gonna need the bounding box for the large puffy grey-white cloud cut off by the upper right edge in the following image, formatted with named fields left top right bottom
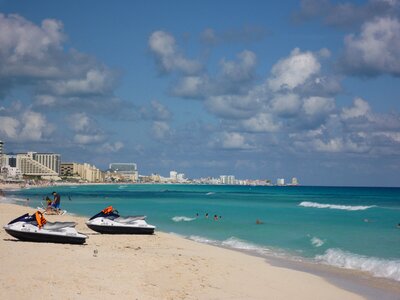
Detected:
left=341, top=18, right=400, bottom=76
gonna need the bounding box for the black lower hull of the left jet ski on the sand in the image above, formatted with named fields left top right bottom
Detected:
left=4, top=228, right=86, bottom=244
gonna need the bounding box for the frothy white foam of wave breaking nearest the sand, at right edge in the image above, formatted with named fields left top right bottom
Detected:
left=315, top=249, right=400, bottom=281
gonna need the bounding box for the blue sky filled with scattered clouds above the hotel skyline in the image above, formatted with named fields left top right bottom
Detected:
left=0, top=0, right=400, bottom=186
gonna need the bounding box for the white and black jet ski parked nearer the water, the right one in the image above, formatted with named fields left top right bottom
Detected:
left=86, top=206, right=156, bottom=234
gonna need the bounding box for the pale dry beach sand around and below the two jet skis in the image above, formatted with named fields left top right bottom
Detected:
left=0, top=204, right=376, bottom=299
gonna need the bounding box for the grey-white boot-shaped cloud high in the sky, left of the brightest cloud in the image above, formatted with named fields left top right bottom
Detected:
left=149, top=30, right=202, bottom=74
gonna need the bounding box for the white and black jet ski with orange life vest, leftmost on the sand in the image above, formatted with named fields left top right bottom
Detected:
left=4, top=211, right=87, bottom=244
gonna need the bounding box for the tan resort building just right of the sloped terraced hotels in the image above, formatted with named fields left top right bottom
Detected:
left=61, top=162, right=104, bottom=182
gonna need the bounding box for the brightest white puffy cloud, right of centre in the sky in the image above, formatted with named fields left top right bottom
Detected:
left=268, top=48, right=321, bottom=92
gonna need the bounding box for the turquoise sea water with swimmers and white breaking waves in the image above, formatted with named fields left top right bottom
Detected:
left=6, top=185, right=400, bottom=281
